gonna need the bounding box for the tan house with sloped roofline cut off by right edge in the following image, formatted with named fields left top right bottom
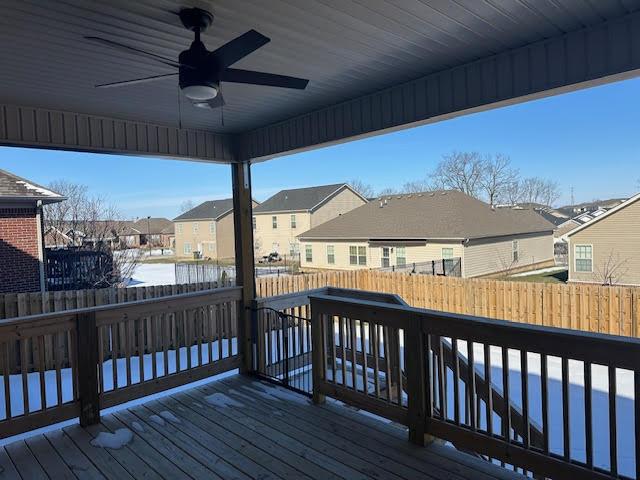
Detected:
left=566, top=193, right=640, bottom=285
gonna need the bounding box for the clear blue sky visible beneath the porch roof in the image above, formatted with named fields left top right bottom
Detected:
left=0, top=75, right=640, bottom=218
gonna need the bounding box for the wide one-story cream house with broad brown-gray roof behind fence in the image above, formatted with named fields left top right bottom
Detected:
left=299, top=190, right=554, bottom=277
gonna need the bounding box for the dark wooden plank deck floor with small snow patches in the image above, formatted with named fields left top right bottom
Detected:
left=0, top=376, right=523, bottom=480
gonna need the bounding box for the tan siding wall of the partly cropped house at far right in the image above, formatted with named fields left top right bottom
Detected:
left=569, top=201, right=640, bottom=285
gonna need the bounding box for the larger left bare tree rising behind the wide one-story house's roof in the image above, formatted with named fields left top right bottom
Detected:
left=430, top=152, right=484, bottom=198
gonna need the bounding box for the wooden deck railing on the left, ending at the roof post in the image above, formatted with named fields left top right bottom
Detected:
left=0, top=287, right=241, bottom=438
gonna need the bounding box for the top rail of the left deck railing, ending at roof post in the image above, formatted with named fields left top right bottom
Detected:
left=0, top=287, right=242, bottom=327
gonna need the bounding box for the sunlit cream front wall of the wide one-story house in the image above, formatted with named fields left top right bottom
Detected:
left=300, top=240, right=462, bottom=270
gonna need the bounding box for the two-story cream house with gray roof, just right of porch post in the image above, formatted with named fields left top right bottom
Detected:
left=253, top=183, right=367, bottom=256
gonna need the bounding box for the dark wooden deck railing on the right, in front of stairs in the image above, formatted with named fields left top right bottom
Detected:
left=311, top=295, right=640, bottom=478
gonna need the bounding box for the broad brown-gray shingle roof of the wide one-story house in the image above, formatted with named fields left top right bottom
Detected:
left=299, top=190, right=554, bottom=240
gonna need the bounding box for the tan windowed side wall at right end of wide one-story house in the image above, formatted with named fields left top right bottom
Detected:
left=462, top=232, right=553, bottom=277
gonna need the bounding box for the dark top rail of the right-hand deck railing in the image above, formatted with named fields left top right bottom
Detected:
left=311, top=295, right=640, bottom=370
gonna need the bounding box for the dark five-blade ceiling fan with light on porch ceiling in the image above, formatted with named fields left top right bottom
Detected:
left=84, top=8, right=309, bottom=108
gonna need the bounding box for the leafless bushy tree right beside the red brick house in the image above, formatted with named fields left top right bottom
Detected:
left=44, top=180, right=139, bottom=285
